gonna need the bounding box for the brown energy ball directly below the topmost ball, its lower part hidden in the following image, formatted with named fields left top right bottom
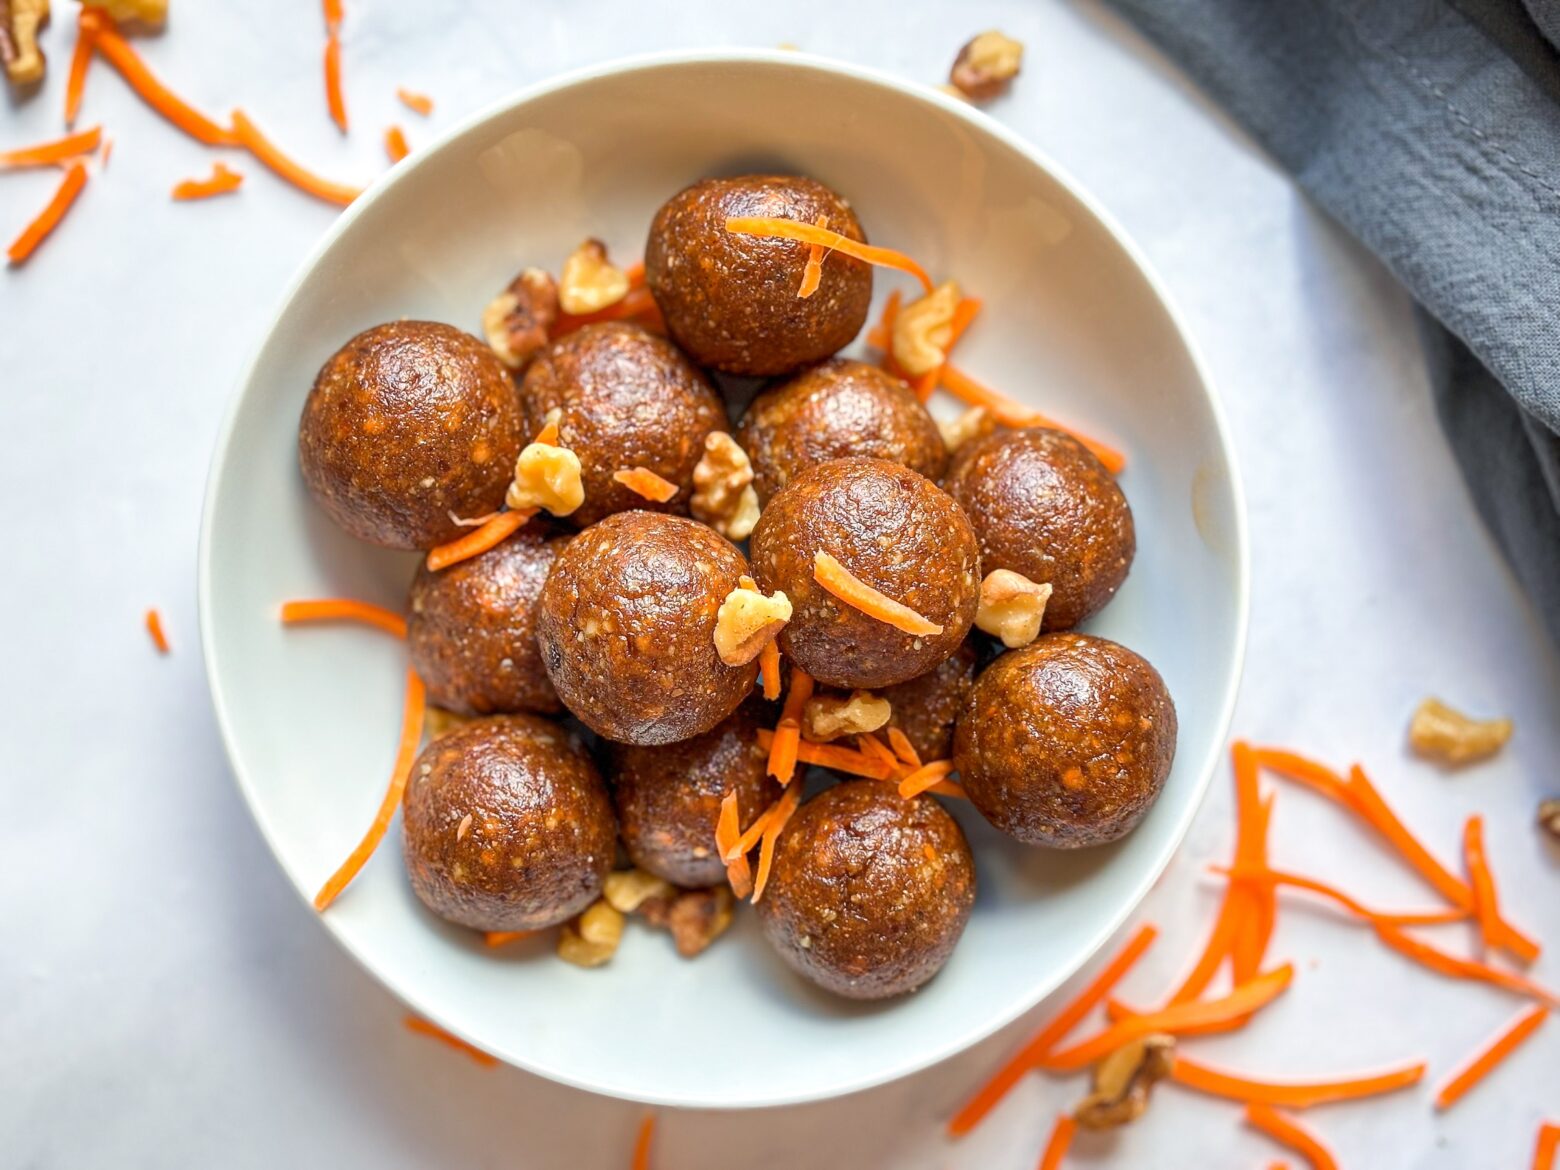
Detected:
left=736, top=357, right=948, bottom=504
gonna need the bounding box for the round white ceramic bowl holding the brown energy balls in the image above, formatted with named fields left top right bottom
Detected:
left=200, top=51, right=1246, bottom=1108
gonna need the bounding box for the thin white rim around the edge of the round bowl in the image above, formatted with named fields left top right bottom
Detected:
left=197, top=47, right=1251, bottom=1111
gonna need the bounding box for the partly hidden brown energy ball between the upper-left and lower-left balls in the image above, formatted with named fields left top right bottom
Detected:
left=406, top=521, right=569, bottom=714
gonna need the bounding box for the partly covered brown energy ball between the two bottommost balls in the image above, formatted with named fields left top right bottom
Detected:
left=608, top=700, right=780, bottom=886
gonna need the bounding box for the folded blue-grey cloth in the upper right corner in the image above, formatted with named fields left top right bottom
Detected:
left=1106, top=0, right=1560, bottom=643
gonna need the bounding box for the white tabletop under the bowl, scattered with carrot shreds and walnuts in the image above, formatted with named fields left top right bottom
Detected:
left=0, top=0, right=1560, bottom=1170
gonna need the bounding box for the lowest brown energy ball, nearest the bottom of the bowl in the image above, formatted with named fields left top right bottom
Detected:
left=758, top=780, right=975, bottom=1000
